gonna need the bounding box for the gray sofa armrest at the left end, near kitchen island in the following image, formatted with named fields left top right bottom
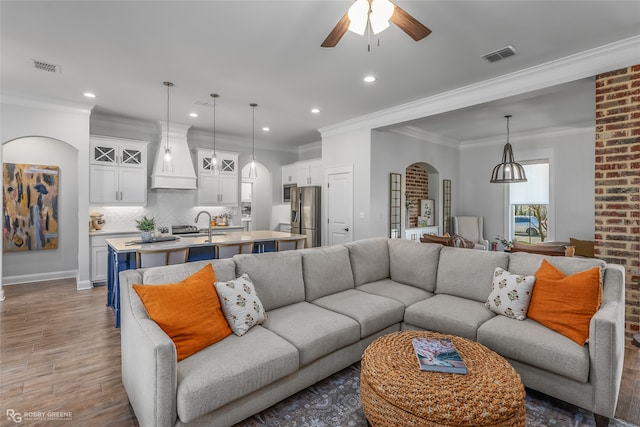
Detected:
left=120, top=270, right=178, bottom=427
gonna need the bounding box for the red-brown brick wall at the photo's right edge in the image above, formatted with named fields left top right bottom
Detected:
left=595, top=65, right=640, bottom=346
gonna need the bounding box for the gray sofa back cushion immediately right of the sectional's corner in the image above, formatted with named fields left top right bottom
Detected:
left=388, top=239, right=442, bottom=292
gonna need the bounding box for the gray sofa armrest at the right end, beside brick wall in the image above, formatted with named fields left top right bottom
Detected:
left=589, top=264, right=625, bottom=418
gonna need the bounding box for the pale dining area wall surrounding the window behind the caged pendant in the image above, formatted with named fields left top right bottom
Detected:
left=460, top=125, right=595, bottom=241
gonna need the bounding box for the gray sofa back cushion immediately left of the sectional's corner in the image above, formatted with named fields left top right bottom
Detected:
left=344, top=237, right=389, bottom=286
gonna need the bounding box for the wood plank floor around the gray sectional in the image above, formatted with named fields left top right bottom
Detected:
left=0, top=280, right=640, bottom=427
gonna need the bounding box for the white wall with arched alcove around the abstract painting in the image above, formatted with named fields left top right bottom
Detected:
left=0, top=94, right=91, bottom=289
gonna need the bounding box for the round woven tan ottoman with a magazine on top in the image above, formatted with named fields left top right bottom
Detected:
left=360, top=331, right=526, bottom=427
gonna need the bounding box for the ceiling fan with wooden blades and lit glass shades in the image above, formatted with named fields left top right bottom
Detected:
left=321, top=0, right=431, bottom=47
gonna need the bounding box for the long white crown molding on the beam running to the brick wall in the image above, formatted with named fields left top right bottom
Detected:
left=318, top=36, right=640, bottom=138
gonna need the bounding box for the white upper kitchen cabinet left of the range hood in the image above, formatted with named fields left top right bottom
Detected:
left=89, top=135, right=147, bottom=205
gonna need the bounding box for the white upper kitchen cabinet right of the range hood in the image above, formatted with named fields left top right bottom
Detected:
left=198, top=149, right=239, bottom=206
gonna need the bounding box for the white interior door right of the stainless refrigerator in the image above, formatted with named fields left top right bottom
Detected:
left=327, top=171, right=353, bottom=245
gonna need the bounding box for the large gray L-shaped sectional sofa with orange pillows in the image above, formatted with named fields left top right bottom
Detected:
left=120, top=238, right=624, bottom=426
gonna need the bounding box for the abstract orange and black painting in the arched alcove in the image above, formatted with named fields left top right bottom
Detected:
left=2, top=163, right=60, bottom=252
